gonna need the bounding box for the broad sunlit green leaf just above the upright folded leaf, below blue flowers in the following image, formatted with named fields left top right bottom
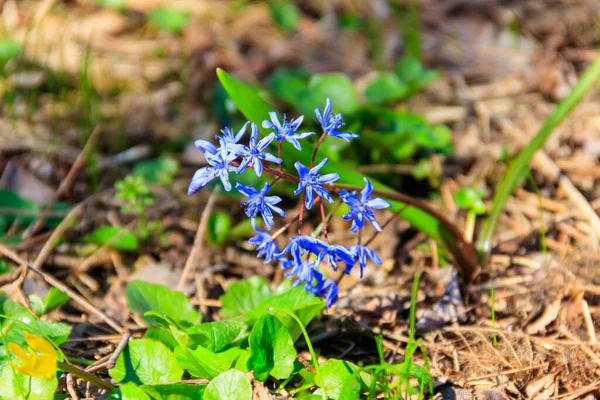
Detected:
left=248, top=287, right=325, bottom=340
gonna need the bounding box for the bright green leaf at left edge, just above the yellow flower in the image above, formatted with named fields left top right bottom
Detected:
left=0, top=292, right=71, bottom=346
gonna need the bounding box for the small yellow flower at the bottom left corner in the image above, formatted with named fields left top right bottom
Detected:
left=8, top=332, right=58, bottom=379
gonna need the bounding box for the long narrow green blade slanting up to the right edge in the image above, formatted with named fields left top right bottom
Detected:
left=477, top=57, right=600, bottom=255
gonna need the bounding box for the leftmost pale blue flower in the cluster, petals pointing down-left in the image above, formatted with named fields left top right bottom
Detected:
left=188, top=142, right=237, bottom=194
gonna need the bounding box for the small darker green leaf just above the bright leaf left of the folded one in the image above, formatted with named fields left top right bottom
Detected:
left=186, top=318, right=248, bottom=351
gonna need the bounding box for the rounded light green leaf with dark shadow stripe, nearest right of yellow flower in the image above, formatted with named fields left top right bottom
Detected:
left=108, top=339, right=183, bottom=385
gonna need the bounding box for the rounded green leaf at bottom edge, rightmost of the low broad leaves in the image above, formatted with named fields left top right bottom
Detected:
left=315, top=359, right=361, bottom=400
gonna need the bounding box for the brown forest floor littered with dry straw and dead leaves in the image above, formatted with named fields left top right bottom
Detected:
left=0, top=0, right=600, bottom=399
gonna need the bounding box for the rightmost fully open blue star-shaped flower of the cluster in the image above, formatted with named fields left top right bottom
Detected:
left=340, top=178, right=390, bottom=232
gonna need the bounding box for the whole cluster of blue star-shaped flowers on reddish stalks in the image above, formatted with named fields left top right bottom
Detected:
left=188, top=99, right=390, bottom=308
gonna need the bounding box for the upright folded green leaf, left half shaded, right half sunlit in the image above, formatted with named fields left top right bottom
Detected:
left=247, top=314, right=296, bottom=381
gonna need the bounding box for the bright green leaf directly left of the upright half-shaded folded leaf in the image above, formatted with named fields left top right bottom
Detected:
left=175, top=346, right=245, bottom=379
